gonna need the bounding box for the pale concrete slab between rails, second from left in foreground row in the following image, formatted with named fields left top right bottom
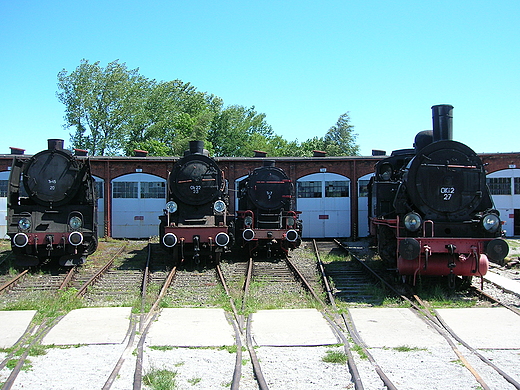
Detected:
left=42, top=307, right=132, bottom=345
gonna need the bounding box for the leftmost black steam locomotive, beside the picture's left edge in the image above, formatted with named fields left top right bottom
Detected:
left=7, top=139, right=98, bottom=266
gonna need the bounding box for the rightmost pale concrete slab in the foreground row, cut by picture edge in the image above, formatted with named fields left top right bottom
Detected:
left=437, top=307, right=520, bottom=349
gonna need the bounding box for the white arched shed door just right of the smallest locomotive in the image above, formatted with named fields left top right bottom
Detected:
left=296, top=172, right=351, bottom=238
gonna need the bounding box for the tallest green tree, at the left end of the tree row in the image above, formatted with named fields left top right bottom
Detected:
left=57, top=59, right=151, bottom=155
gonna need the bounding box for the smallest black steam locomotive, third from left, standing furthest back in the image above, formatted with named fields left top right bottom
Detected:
left=235, top=160, right=302, bottom=256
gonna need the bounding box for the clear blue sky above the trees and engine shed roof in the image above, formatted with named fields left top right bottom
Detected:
left=0, top=0, right=520, bottom=155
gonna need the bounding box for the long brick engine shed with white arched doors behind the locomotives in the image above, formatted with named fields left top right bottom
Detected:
left=0, top=148, right=520, bottom=238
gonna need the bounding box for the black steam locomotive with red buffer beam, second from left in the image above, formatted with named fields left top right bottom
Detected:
left=159, top=141, right=230, bottom=263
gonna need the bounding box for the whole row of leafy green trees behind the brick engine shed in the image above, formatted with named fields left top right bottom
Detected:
left=57, top=59, right=359, bottom=156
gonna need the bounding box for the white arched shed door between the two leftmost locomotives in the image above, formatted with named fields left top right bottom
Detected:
left=112, top=173, right=166, bottom=238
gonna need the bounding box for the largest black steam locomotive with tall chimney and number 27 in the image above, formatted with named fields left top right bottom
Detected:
left=369, top=105, right=509, bottom=286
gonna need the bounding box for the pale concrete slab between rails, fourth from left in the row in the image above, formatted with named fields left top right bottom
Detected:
left=251, top=309, right=340, bottom=347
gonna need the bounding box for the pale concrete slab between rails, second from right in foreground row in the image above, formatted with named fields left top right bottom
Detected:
left=349, top=308, right=446, bottom=348
